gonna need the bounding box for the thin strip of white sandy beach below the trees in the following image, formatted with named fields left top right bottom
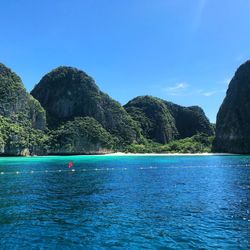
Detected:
left=102, top=152, right=235, bottom=156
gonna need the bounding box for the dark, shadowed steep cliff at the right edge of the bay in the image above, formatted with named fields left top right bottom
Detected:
left=214, top=61, right=250, bottom=154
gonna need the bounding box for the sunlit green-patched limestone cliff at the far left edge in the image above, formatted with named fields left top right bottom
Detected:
left=0, top=64, right=46, bottom=155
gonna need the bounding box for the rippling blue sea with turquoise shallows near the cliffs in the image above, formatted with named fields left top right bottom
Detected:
left=0, top=156, right=250, bottom=249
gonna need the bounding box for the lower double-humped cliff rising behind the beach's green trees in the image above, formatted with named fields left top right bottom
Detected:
left=124, top=96, right=214, bottom=143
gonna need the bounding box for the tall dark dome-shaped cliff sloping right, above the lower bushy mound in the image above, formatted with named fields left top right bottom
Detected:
left=31, top=67, right=141, bottom=144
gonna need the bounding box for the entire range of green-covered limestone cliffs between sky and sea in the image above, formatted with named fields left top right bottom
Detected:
left=0, top=61, right=250, bottom=155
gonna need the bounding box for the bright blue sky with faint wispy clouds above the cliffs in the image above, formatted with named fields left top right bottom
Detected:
left=0, top=0, right=250, bottom=122
